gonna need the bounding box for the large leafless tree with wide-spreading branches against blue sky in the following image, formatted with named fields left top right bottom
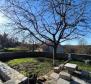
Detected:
left=1, top=0, right=90, bottom=64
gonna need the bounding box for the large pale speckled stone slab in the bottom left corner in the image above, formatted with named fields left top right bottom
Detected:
left=0, top=62, right=27, bottom=84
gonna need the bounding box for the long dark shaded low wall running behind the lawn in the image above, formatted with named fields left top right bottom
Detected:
left=0, top=52, right=91, bottom=61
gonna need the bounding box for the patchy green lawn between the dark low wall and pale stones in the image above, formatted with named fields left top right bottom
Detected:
left=6, top=57, right=91, bottom=76
